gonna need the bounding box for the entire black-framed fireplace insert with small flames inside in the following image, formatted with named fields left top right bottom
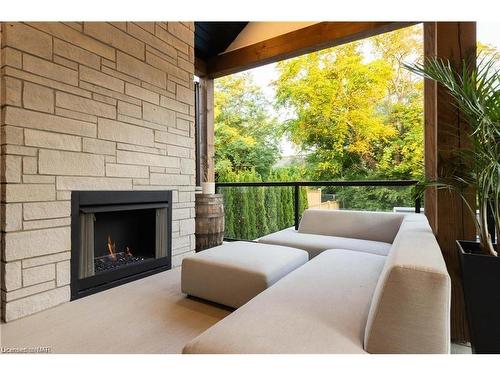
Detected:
left=71, top=191, right=172, bottom=299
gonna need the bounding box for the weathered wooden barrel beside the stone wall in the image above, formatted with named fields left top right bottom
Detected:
left=195, top=194, right=224, bottom=252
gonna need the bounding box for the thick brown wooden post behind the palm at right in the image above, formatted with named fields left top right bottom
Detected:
left=424, top=22, right=476, bottom=342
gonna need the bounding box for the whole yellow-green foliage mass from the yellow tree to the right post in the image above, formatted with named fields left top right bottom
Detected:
left=275, top=27, right=423, bottom=187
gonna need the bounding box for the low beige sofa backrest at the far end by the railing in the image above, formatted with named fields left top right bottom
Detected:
left=299, top=209, right=404, bottom=243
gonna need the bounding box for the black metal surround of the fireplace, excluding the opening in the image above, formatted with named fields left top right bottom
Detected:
left=71, top=190, right=172, bottom=300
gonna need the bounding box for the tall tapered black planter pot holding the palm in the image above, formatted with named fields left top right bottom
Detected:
left=457, top=241, right=500, bottom=354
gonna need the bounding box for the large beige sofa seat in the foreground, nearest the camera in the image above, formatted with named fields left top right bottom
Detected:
left=183, top=250, right=386, bottom=354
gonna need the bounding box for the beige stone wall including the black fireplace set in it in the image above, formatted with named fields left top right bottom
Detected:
left=0, top=22, right=195, bottom=321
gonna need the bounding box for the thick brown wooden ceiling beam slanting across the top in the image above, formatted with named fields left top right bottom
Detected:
left=207, top=22, right=418, bottom=78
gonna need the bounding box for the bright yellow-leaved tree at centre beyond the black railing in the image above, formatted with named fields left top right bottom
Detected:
left=275, top=43, right=395, bottom=179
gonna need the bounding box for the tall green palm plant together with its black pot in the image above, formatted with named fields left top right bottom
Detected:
left=406, top=55, right=500, bottom=353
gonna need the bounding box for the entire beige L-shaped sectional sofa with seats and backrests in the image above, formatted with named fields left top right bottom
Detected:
left=184, top=210, right=451, bottom=353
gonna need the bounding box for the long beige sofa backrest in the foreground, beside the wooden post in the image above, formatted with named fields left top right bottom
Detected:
left=364, top=215, right=451, bottom=353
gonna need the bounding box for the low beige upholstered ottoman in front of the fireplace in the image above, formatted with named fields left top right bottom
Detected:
left=181, top=242, right=309, bottom=308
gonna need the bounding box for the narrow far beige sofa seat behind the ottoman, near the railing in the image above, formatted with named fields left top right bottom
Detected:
left=258, top=228, right=392, bottom=259
